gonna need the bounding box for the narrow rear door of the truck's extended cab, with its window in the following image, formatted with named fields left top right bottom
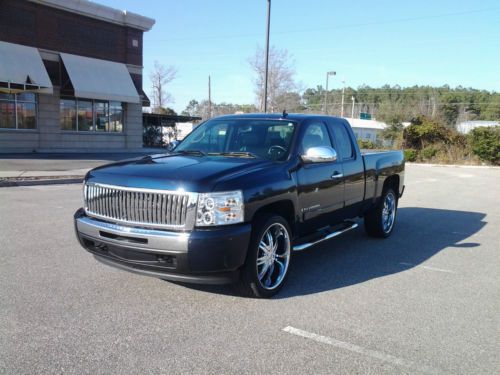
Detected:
left=328, top=119, right=365, bottom=212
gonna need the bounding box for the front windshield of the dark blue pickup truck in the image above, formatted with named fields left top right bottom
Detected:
left=174, top=119, right=295, bottom=161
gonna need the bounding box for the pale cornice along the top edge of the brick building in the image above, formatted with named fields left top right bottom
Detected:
left=29, top=0, right=155, bottom=31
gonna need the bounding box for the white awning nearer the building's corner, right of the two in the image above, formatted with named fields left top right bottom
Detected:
left=60, top=53, right=141, bottom=103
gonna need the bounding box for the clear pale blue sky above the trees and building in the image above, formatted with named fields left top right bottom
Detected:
left=97, top=0, right=500, bottom=113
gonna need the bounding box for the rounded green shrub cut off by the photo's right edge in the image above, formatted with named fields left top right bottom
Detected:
left=469, top=126, right=500, bottom=165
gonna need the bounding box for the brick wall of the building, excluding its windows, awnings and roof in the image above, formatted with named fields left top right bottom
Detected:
left=0, top=0, right=148, bottom=152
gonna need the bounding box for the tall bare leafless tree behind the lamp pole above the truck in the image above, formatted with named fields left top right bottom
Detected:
left=248, top=46, right=297, bottom=112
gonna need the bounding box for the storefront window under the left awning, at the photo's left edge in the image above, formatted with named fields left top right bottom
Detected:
left=0, top=93, right=37, bottom=129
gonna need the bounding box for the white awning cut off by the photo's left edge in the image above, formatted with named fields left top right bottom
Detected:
left=0, top=41, right=52, bottom=94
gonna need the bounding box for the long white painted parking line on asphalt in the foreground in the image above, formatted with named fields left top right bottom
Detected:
left=283, top=326, right=444, bottom=374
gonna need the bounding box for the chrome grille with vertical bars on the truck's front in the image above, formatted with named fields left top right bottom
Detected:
left=84, top=184, right=196, bottom=229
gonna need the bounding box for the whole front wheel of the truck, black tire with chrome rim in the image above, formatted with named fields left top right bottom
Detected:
left=239, top=214, right=292, bottom=298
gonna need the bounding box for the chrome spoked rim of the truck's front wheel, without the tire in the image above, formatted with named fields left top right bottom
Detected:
left=256, top=223, right=291, bottom=290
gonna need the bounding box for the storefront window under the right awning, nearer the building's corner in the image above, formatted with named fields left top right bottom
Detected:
left=60, top=98, right=124, bottom=132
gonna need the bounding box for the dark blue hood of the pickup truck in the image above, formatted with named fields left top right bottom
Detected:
left=87, top=155, right=274, bottom=192
